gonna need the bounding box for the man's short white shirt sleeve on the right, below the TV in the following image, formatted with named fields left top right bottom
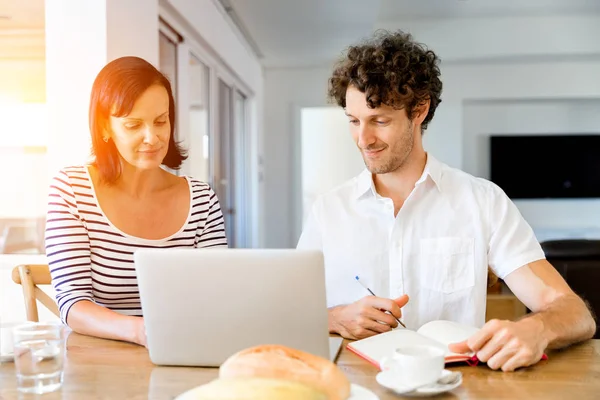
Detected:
left=488, top=184, right=545, bottom=279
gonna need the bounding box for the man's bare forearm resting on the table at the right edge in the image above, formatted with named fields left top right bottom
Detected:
left=522, top=294, right=596, bottom=349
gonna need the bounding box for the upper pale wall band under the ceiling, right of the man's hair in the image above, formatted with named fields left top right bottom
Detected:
left=375, top=15, right=600, bottom=62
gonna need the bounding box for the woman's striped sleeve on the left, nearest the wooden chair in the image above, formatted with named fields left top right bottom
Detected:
left=46, top=171, right=94, bottom=324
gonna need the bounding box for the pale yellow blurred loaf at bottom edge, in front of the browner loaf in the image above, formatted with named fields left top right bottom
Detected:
left=177, top=378, right=327, bottom=400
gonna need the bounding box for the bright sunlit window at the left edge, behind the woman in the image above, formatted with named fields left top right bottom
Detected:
left=0, top=89, right=48, bottom=254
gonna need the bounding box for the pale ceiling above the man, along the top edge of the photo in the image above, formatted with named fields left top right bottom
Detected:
left=226, top=0, right=600, bottom=67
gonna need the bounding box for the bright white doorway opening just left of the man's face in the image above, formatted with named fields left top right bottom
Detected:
left=301, top=107, right=365, bottom=221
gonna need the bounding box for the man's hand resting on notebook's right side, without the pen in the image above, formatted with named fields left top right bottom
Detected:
left=448, top=318, right=548, bottom=372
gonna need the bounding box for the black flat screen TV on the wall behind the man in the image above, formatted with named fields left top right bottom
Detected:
left=490, top=134, right=600, bottom=199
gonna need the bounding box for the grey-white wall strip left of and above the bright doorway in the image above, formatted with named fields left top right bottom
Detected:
left=264, top=68, right=331, bottom=248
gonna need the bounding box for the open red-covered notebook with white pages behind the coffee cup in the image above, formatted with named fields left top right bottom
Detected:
left=346, top=321, right=546, bottom=369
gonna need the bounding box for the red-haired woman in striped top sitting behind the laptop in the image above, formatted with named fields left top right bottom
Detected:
left=46, top=57, right=227, bottom=346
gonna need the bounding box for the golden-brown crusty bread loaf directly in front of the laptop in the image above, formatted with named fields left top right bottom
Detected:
left=219, top=345, right=350, bottom=400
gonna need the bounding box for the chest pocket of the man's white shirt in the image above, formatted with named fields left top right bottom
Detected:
left=419, top=237, right=475, bottom=293
